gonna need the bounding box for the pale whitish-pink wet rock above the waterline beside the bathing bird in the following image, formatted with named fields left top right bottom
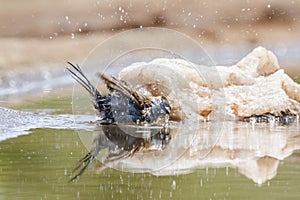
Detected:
left=119, top=47, right=300, bottom=120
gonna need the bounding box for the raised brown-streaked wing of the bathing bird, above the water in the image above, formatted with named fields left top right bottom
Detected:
left=98, top=74, right=151, bottom=109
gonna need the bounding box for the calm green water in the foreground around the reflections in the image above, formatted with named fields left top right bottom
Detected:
left=0, top=98, right=300, bottom=200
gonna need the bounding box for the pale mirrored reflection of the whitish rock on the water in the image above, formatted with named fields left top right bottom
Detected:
left=96, top=121, right=300, bottom=184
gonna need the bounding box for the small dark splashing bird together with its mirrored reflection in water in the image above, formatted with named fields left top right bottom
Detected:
left=67, top=62, right=171, bottom=181
